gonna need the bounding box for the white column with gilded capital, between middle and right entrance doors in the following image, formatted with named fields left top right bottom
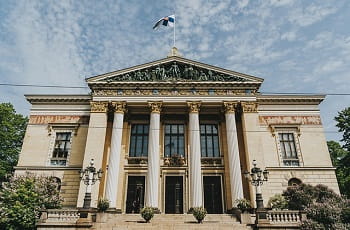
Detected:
left=187, top=102, right=203, bottom=208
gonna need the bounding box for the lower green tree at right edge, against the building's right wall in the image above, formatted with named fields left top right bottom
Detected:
left=327, top=141, right=350, bottom=198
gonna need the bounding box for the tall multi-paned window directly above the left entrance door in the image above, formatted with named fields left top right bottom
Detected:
left=129, top=124, right=149, bottom=157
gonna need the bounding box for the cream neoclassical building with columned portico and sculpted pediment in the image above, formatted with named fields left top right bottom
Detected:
left=16, top=50, right=339, bottom=213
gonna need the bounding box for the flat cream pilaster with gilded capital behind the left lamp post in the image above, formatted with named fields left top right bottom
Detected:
left=77, top=101, right=108, bottom=207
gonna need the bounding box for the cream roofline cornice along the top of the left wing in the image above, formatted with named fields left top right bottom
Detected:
left=24, top=94, right=91, bottom=104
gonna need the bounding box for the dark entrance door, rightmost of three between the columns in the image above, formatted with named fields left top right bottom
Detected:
left=203, top=176, right=222, bottom=214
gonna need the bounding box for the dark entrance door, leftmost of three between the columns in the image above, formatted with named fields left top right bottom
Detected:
left=125, top=176, right=145, bottom=213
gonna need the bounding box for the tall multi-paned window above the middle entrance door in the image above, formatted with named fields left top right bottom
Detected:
left=164, top=124, right=185, bottom=157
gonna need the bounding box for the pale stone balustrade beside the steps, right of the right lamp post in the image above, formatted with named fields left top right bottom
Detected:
left=267, top=210, right=306, bottom=224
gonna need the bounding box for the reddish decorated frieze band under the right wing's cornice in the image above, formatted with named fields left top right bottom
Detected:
left=259, top=116, right=322, bottom=125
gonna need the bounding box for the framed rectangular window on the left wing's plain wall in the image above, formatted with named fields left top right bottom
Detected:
left=51, top=132, right=72, bottom=166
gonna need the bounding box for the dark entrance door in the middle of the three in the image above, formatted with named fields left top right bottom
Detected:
left=165, top=176, right=183, bottom=214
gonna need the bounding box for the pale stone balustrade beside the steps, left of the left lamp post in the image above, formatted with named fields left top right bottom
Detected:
left=40, top=209, right=79, bottom=223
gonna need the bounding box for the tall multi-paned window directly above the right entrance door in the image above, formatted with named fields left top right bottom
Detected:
left=200, top=124, right=220, bottom=157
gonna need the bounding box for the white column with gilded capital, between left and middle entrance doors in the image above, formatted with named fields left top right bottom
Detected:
left=145, top=102, right=162, bottom=209
